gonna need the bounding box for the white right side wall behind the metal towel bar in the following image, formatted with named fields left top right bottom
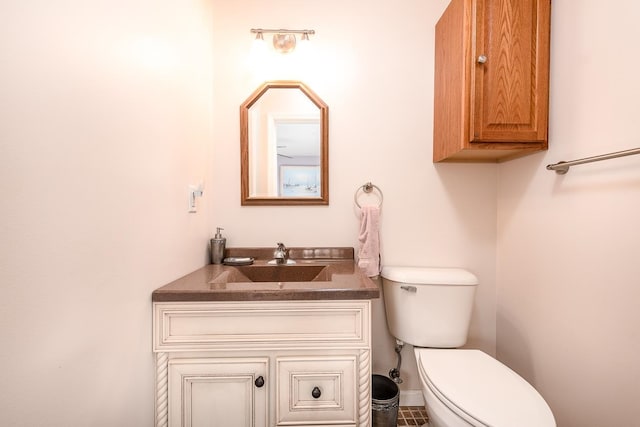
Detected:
left=497, top=0, right=640, bottom=427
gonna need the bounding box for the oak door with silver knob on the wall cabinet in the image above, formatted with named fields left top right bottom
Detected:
left=471, top=0, right=551, bottom=148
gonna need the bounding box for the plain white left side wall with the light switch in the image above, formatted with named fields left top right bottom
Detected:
left=0, top=0, right=212, bottom=427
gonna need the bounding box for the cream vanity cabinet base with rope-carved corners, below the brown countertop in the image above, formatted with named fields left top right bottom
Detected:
left=153, top=300, right=371, bottom=427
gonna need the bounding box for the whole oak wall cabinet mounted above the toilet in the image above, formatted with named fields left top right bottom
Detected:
left=433, top=0, right=551, bottom=162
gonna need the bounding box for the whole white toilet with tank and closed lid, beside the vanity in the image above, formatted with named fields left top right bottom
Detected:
left=381, top=266, right=556, bottom=427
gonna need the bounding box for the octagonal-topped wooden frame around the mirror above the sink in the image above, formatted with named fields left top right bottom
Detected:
left=240, top=81, right=329, bottom=206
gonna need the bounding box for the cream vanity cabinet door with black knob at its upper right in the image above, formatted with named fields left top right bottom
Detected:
left=168, top=358, right=269, bottom=427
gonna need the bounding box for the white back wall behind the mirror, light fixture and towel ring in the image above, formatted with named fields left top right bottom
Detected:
left=213, top=0, right=497, bottom=389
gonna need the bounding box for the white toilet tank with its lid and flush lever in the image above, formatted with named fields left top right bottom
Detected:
left=381, top=266, right=478, bottom=348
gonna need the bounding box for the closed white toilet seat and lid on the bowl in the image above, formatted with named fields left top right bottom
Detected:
left=415, top=348, right=556, bottom=427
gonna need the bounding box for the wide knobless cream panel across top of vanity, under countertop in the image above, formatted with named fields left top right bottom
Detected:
left=153, top=300, right=370, bottom=352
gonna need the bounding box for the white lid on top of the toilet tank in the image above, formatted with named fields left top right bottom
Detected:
left=382, top=265, right=478, bottom=286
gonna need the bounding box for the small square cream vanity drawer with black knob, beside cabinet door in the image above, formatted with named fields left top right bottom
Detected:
left=276, top=354, right=358, bottom=426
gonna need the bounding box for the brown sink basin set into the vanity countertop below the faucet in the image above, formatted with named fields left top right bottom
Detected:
left=236, top=265, right=330, bottom=282
